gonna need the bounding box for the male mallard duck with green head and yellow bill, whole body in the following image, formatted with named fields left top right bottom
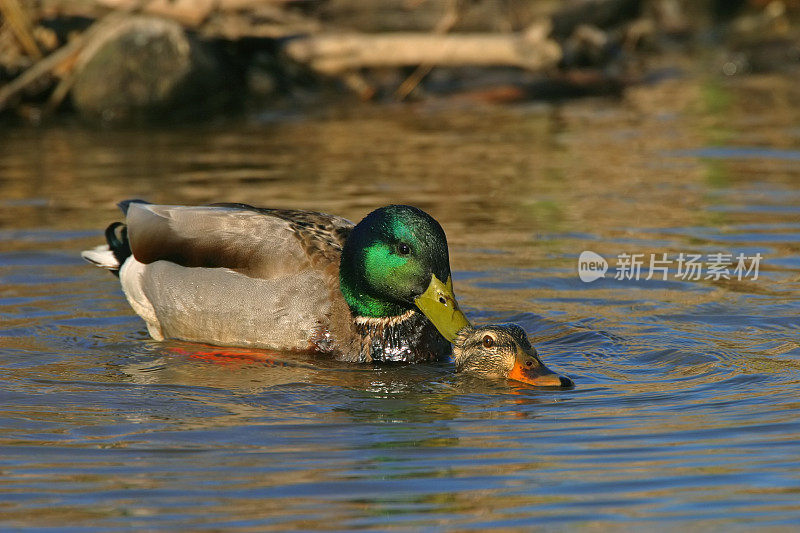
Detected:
left=81, top=200, right=469, bottom=362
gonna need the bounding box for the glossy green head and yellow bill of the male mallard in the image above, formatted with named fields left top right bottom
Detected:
left=339, top=205, right=469, bottom=341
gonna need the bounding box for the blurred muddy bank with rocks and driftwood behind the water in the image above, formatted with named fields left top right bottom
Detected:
left=0, top=0, right=800, bottom=123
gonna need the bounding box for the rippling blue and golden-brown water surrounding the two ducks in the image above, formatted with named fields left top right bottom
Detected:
left=0, top=79, right=800, bottom=531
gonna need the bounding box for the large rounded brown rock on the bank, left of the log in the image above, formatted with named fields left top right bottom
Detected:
left=71, top=16, right=235, bottom=123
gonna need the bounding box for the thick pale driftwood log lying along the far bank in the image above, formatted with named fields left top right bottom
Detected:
left=284, top=24, right=561, bottom=75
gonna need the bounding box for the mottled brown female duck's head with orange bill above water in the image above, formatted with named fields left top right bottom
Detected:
left=453, top=324, right=573, bottom=388
